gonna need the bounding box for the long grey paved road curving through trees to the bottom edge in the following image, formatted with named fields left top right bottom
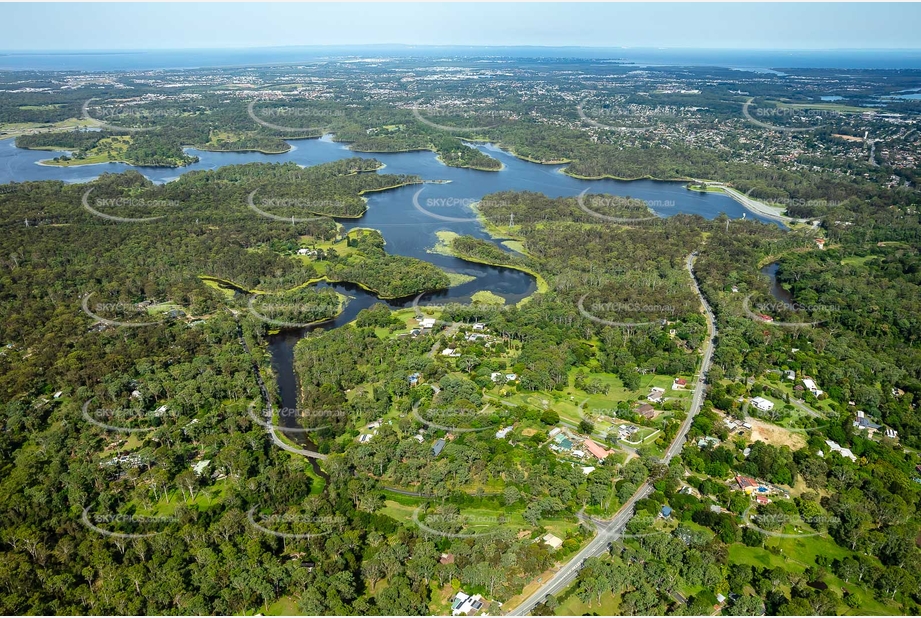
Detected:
left=507, top=254, right=716, bottom=616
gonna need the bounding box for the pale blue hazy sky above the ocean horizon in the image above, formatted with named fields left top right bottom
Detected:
left=0, top=3, right=921, bottom=51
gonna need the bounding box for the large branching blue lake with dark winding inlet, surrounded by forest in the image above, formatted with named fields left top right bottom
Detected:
left=0, top=137, right=772, bottom=440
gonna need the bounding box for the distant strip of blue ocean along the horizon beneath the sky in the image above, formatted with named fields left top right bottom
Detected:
left=0, top=45, right=921, bottom=71
